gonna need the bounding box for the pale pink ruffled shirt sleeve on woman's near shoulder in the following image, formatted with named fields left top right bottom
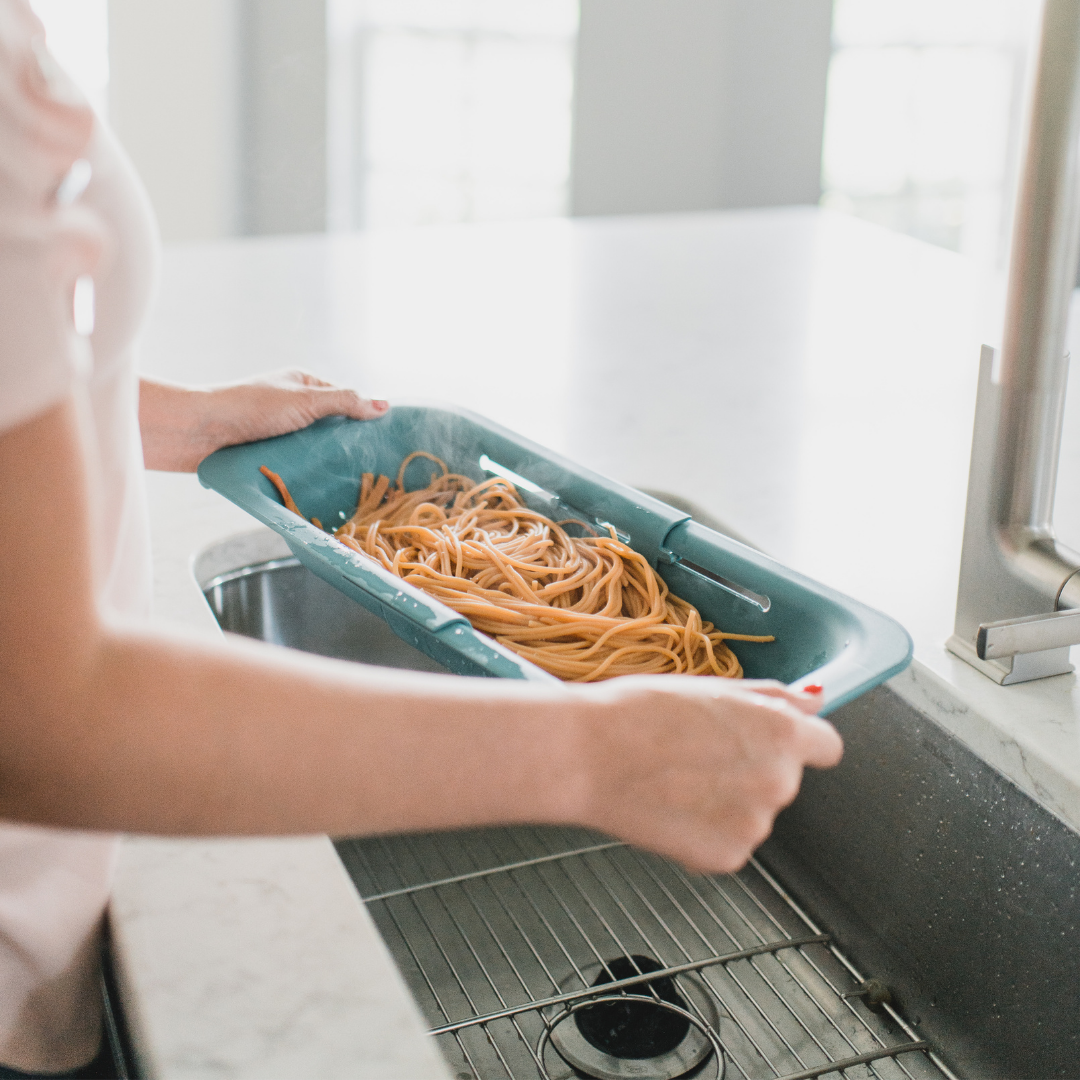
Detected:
left=0, top=0, right=96, bottom=431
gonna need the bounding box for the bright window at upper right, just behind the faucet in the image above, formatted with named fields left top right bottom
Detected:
left=822, top=0, right=1038, bottom=265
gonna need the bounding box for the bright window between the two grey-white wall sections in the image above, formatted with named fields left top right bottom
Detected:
left=329, top=0, right=578, bottom=228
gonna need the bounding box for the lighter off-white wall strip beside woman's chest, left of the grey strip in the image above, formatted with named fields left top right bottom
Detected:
left=109, top=0, right=240, bottom=241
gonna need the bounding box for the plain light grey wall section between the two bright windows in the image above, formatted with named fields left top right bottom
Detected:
left=570, top=0, right=832, bottom=214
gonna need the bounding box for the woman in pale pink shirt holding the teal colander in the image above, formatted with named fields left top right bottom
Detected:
left=0, top=0, right=841, bottom=1075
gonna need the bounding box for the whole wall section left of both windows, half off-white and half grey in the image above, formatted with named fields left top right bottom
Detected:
left=109, top=0, right=326, bottom=242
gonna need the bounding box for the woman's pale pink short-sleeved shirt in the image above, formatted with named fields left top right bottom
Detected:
left=0, top=0, right=158, bottom=1071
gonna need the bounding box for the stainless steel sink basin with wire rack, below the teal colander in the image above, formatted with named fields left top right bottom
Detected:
left=195, top=530, right=1080, bottom=1080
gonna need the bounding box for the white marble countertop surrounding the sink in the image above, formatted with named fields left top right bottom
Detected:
left=117, top=208, right=1080, bottom=1077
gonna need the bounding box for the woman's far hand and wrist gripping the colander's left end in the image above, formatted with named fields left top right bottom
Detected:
left=138, top=370, right=389, bottom=472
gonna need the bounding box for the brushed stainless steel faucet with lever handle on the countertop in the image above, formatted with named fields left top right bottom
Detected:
left=948, top=0, right=1080, bottom=684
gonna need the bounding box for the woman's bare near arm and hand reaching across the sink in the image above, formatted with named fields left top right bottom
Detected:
left=0, top=393, right=840, bottom=870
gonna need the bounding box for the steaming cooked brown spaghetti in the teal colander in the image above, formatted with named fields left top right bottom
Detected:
left=260, top=450, right=772, bottom=683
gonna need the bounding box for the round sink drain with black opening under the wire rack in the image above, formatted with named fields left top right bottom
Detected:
left=538, top=955, right=724, bottom=1080
